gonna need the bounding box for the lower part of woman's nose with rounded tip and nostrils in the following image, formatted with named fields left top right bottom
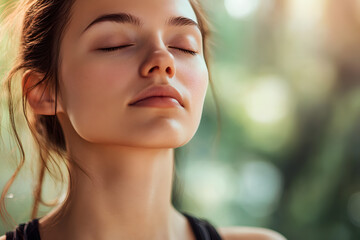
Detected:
left=140, top=48, right=176, bottom=78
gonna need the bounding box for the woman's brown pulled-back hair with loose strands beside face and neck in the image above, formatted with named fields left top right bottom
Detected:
left=0, top=0, right=220, bottom=227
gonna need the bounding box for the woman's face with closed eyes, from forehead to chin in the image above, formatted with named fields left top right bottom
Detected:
left=58, top=0, right=208, bottom=148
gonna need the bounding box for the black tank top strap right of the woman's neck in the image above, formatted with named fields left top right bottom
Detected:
left=182, top=212, right=222, bottom=240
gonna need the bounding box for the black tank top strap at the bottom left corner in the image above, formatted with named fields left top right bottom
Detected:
left=5, top=219, right=40, bottom=240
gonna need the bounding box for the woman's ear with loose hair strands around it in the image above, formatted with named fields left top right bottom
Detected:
left=21, top=70, right=62, bottom=115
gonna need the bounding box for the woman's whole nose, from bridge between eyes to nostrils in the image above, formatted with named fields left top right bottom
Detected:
left=140, top=35, right=176, bottom=78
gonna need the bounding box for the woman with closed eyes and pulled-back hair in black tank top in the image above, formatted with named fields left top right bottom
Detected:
left=0, top=0, right=283, bottom=240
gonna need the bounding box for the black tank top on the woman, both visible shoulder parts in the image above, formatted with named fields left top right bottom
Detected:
left=6, top=212, right=222, bottom=240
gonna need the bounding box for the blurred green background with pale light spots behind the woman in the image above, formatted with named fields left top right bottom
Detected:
left=0, top=0, right=360, bottom=240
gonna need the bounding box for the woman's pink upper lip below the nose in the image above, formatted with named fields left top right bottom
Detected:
left=129, top=85, right=184, bottom=106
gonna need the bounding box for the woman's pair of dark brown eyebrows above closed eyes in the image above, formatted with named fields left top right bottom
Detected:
left=83, top=13, right=200, bottom=33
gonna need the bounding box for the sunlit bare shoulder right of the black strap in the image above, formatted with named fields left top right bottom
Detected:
left=217, top=226, right=286, bottom=240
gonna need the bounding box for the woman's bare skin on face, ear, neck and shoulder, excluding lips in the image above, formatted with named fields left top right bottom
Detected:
left=0, top=0, right=283, bottom=240
